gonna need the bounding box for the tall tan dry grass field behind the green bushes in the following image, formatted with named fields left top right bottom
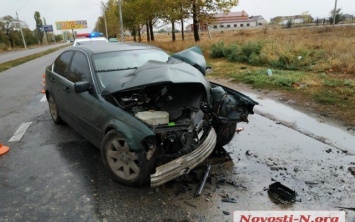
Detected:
left=149, top=26, right=355, bottom=74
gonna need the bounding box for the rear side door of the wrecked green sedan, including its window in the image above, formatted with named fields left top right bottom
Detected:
left=46, top=51, right=74, bottom=122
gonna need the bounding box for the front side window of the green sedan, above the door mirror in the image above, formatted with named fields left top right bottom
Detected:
left=68, top=52, right=90, bottom=82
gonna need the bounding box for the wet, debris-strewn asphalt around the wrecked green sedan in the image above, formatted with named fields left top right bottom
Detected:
left=0, top=76, right=355, bottom=221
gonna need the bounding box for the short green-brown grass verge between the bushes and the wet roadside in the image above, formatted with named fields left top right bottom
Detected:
left=208, top=59, right=355, bottom=128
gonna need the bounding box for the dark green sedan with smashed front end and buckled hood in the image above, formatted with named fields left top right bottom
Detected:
left=45, top=43, right=257, bottom=186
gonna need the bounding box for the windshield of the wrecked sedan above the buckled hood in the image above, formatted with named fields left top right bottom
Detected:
left=93, top=49, right=169, bottom=87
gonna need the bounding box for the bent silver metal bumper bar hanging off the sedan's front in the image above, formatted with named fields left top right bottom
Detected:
left=150, top=128, right=217, bottom=187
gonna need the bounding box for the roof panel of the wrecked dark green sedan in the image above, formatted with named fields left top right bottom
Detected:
left=72, top=42, right=161, bottom=55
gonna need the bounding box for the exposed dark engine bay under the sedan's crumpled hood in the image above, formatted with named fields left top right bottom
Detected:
left=107, top=83, right=217, bottom=163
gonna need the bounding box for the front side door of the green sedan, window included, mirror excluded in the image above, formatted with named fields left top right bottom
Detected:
left=68, top=51, right=103, bottom=146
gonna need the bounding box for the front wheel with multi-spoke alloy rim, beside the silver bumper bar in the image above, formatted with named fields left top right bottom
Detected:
left=101, top=130, right=155, bottom=187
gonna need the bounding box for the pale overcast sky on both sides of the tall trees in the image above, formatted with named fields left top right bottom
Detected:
left=0, top=0, right=355, bottom=33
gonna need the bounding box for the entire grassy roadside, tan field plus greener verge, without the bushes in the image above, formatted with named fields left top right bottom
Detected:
left=145, top=26, right=355, bottom=127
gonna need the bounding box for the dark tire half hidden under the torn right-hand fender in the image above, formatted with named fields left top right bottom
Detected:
left=215, top=122, right=237, bottom=147
